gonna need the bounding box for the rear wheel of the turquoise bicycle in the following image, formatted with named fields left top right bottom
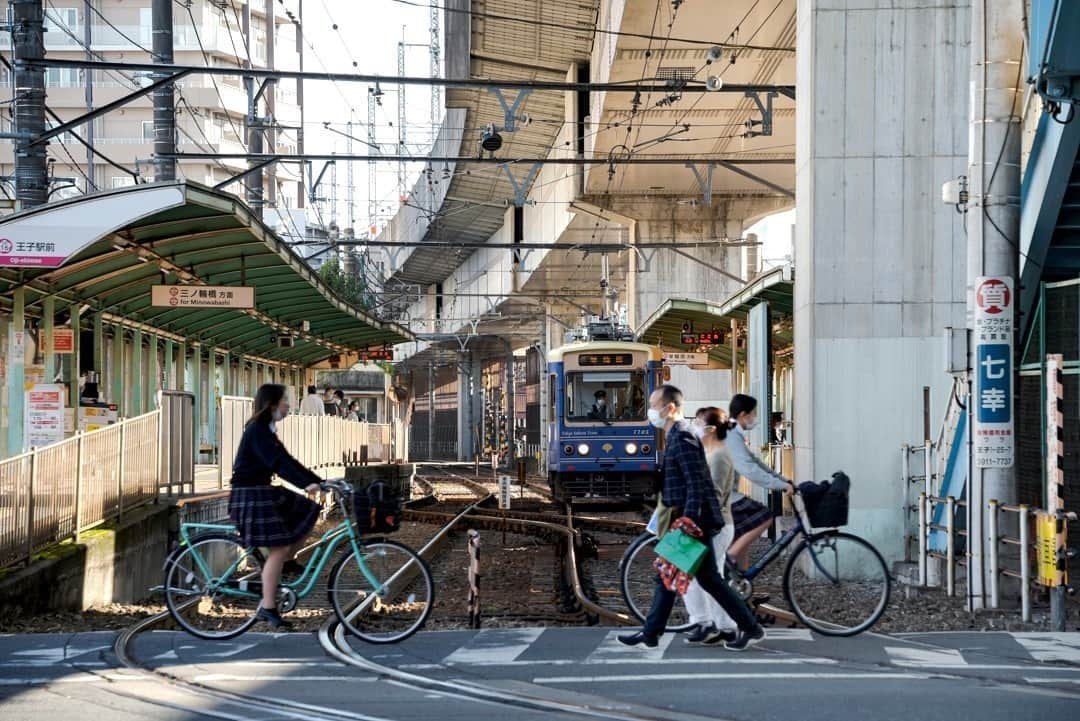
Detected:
left=165, top=535, right=262, bottom=639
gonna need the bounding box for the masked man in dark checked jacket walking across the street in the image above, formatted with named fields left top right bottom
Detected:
left=619, top=385, right=765, bottom=651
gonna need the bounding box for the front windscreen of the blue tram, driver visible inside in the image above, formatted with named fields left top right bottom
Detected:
left=565, top=370, right=646, bottom=422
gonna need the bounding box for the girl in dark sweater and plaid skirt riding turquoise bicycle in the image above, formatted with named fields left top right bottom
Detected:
left=229, top=383, right=321, bottom=628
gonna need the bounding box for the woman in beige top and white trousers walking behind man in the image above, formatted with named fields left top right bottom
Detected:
left=683, top=406, right=738, bottom=644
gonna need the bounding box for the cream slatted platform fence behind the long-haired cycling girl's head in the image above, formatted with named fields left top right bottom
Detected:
left=217, top=396, right=403, bottom=488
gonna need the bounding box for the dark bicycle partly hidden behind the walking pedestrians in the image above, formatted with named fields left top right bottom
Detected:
left=619, top=479, right=891, bottom=636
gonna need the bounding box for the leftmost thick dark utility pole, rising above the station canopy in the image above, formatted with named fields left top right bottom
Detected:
left=11, top=0, right=49, bottom=208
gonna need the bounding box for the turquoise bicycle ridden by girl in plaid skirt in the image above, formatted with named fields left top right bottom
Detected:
left=164, top=480, right=434, bottom=643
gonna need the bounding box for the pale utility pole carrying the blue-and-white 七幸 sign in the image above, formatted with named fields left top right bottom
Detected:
left=967, top=0, right=1025, bottom=609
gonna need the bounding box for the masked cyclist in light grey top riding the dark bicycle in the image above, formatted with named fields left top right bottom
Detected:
left=728, top=393, right=794, bottom=569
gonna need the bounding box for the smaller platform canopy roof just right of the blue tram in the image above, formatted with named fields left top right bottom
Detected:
left=637, top=266, right=795, bottom=368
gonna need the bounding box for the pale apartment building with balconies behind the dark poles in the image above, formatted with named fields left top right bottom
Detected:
left=0, top=0, right=302, bottom=225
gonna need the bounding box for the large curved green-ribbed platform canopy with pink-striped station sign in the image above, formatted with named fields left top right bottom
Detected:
left=0, top=181, right=413, bottom=366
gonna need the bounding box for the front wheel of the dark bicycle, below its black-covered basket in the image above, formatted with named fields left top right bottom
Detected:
left=784, top=531, right=890, bottom=636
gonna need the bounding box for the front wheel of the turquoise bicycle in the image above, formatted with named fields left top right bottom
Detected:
left=329, top=541, right=435, bottom=643
